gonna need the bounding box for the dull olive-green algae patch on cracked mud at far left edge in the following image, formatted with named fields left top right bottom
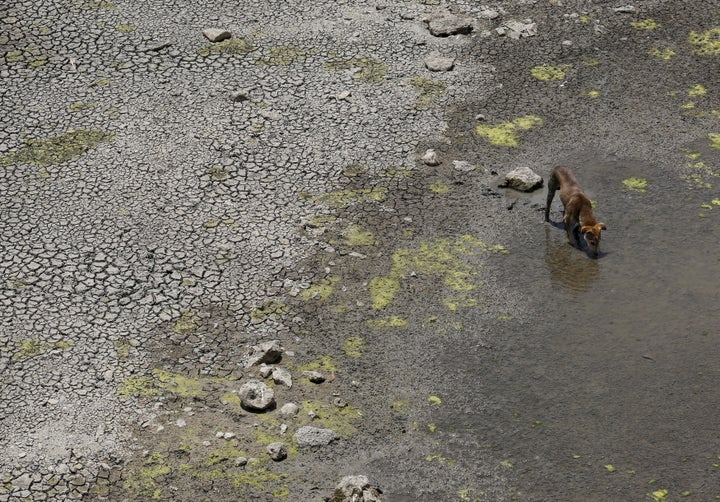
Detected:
left=0, top=129, right=115, bottom=167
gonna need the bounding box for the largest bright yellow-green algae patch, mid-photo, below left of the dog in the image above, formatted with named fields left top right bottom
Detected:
left=369, top=235, right=507, bottom=310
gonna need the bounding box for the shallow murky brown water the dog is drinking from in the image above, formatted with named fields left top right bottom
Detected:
left=441, top=159, right=720, bottom=500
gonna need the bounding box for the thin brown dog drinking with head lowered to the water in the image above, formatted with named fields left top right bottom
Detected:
left=545, top=166, right=607, bottom=258
